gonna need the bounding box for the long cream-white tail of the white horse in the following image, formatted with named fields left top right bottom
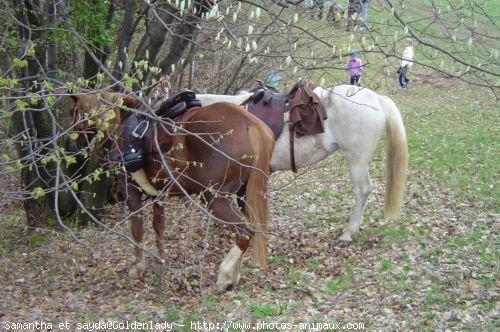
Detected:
left=380, top=96, right=408, bottom=219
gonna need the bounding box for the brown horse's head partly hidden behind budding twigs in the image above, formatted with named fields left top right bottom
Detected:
left=71, top=92, right=140, bottom=148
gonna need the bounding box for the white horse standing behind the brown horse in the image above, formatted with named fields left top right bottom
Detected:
left=196, top=85, right=408, bottom=242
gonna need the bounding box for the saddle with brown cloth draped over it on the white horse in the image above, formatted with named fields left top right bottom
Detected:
left=246, top=80, right=327, bottom=172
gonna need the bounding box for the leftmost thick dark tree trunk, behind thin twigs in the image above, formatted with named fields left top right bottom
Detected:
left=9, top=0, right=81, bottom=227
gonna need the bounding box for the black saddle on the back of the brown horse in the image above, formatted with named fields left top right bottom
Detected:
left=118, top=90, right=201, bottom=172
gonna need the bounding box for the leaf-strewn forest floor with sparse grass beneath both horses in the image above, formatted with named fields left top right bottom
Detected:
left=0, top=77, right=500, bottom=331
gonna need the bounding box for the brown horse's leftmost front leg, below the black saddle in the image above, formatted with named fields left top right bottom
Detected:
left=127, top=186, right=146, bottom=279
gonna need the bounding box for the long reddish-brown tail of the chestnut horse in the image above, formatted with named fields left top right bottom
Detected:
left=245, top=125, right=274, bottom=267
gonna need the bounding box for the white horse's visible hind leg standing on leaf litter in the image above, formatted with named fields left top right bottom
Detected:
left=339, top=153, right=372, bottom=242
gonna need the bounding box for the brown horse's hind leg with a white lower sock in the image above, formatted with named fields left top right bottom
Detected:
left=209, top=197, right=253, bottom=291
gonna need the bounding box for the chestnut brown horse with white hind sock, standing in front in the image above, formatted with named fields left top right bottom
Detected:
left=72, top=94, right=274, bottom=290
